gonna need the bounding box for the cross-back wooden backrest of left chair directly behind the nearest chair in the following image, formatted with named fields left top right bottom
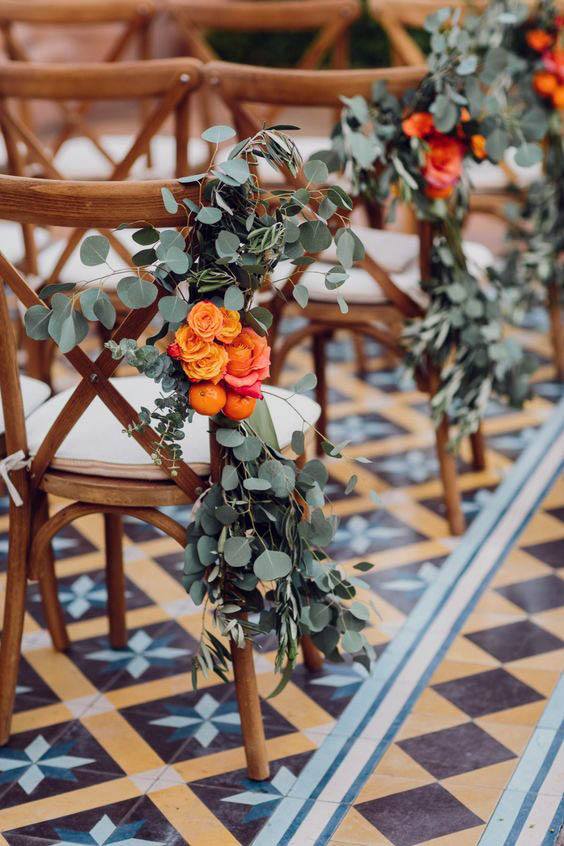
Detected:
left=0, top=59, right=201, bottom=281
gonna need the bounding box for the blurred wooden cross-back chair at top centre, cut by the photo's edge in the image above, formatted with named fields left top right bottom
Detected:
left=168, top=0, right=361, bottom=152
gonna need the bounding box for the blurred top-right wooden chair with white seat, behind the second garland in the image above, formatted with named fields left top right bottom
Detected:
left=368, top=0, right=564, bottom=381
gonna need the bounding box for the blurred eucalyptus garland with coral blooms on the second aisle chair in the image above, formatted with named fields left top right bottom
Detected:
left=319, top=9, right=537, bottom=444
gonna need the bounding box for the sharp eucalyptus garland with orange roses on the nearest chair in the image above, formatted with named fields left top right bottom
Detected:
left=26, top=126, right=373, bottom=688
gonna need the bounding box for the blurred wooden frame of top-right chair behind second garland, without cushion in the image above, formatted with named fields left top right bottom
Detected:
left=368, top=0, right=564, bottom=381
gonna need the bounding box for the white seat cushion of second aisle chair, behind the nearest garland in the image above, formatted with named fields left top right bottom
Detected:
left=273, top=226, right=494, bottom=308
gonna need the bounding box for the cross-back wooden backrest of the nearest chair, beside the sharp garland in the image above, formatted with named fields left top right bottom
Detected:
left=0, top=175, right=205, bottom=499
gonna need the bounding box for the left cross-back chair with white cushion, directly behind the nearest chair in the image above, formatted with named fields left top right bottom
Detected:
left=0, top=59, right=201, bottom=380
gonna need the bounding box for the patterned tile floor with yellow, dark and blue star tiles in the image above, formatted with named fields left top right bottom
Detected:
left=0, top=314, right=564, bottom=846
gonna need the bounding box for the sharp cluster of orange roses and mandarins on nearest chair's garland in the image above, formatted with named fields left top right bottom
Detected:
left=167, top=300, right=270, bottom=420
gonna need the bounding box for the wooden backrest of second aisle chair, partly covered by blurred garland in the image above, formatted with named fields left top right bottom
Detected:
left=203, top=62, right=430, bottom=316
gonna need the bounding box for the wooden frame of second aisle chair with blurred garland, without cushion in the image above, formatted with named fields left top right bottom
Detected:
left=204, top=62, right=485, bottom=535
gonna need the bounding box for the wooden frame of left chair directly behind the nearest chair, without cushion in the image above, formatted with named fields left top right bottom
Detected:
left=0, top=58, right=201, bottom=382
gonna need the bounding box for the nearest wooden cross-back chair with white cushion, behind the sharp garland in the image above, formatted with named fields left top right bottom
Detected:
left=0, top=176, right=319, bottom=779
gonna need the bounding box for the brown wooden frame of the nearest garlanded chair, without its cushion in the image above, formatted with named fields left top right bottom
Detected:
left=0, top=176, right=320, bottom=779
